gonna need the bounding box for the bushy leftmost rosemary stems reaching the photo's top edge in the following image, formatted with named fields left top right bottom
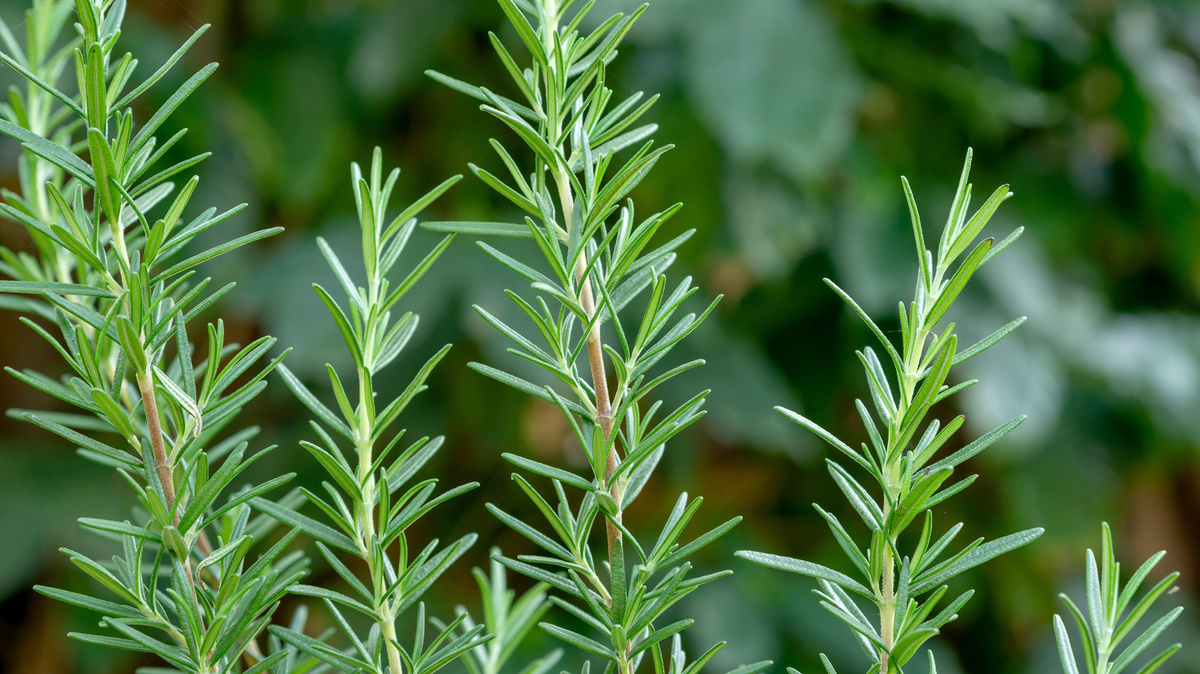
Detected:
left=0, top=0, right=304, bottom=674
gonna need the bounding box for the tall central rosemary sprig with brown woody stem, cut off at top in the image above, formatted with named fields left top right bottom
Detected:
left=425, top=0, right=769, bottom=674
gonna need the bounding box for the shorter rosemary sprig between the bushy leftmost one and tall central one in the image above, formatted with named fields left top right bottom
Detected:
left=256, top=149, right=487, bottom=674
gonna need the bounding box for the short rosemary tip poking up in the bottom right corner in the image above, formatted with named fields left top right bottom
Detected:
left=1054, top=523, right=1183, bottom=674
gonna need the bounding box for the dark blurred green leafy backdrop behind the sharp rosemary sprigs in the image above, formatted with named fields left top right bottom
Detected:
left=0, top=0, right=1200, bottom=674
